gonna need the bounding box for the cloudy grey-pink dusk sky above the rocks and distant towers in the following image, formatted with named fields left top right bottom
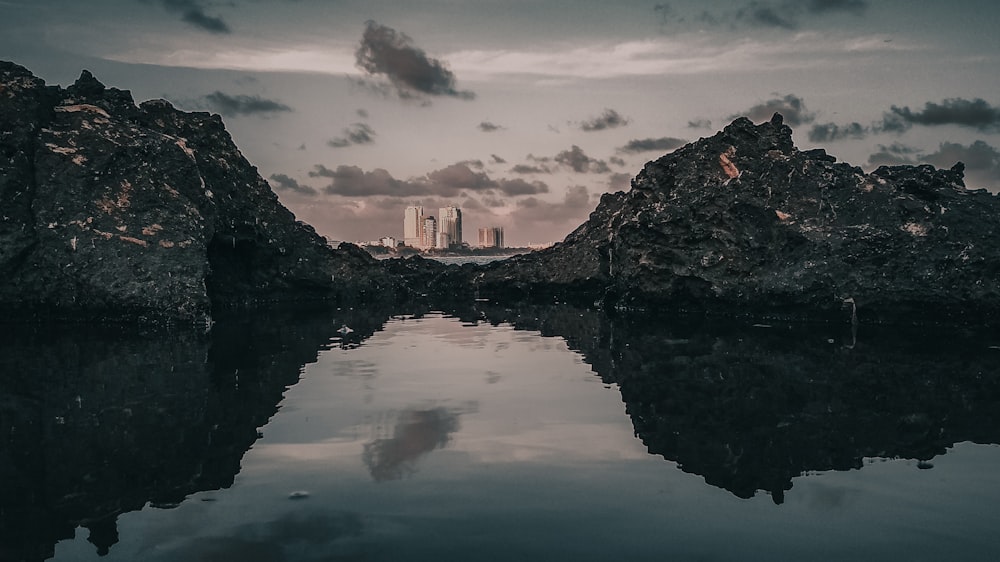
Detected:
left=0, top=0, right=1000, bottom=246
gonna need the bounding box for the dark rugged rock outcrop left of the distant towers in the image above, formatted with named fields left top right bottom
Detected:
left=0, top=62, right=386, bottom=321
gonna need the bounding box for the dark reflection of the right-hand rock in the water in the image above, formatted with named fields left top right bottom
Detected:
left=459, top=306, right=1000, bottom=503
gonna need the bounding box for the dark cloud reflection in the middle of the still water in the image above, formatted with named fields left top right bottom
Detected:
left=362, top=408, right=459, bottom=482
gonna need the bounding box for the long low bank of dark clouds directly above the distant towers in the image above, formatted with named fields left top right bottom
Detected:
left=309, top=161, right=549, bottom=197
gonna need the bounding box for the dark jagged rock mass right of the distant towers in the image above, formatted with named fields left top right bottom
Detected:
left=475, top=114, right=1000, bottom=324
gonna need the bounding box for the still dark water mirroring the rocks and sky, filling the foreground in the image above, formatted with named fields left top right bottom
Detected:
left=0, top=305, right=1000, bottom=562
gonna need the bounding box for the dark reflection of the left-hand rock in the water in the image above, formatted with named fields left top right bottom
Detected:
left=0, top=307, right=388, bottom=560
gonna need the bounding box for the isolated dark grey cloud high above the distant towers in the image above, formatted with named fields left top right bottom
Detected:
left=355, top=20, right=475, bottom=100
